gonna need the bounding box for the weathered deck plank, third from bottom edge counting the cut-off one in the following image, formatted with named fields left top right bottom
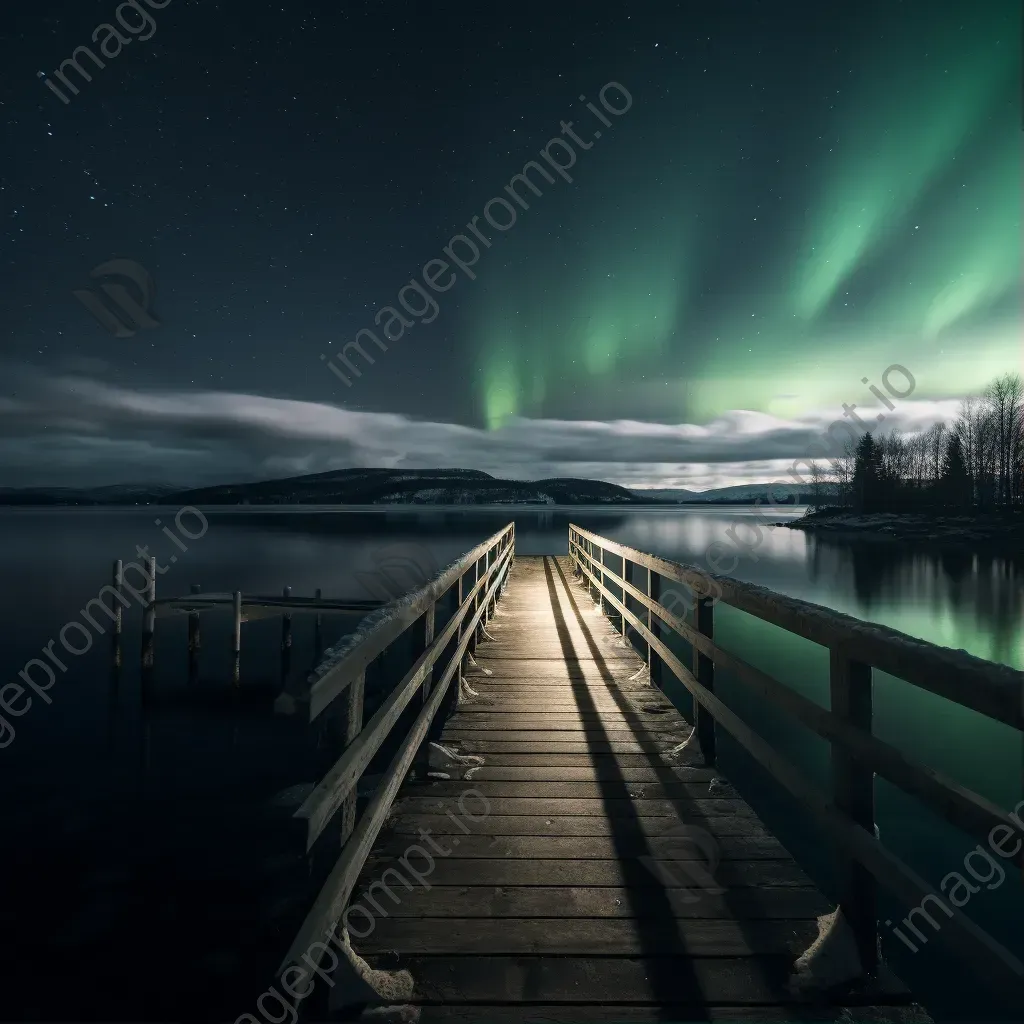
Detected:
left=360, top=921, right=818, bottom=958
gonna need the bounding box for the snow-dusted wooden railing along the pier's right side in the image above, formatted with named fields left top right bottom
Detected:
left=569, top=524, right=1024, bottom=1007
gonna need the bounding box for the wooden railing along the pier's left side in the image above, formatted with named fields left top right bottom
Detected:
left=279, top=523, right=515, bottom=991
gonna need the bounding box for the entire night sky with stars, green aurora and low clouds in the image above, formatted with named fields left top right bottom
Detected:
left=0, top=0, right=1024, bottom=488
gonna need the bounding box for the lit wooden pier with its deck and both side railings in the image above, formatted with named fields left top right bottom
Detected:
left=264, top=524, right=1024, bottom=1024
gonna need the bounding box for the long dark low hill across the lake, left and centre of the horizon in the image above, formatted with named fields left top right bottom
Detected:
left=0, top=469, right=671, bottom=505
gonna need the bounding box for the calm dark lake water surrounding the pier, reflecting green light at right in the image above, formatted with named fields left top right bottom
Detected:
left=0, top=507, right=1024, bottom=1020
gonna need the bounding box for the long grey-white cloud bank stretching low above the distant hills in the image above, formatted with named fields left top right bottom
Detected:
left=0, top=375, right=958, bottom=489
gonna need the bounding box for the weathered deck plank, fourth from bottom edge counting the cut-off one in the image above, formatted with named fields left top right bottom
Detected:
left=353, top=884, right=834, bottom=921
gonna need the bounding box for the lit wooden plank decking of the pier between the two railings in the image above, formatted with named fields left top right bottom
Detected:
left=351, top=557, right=911, bottom=1024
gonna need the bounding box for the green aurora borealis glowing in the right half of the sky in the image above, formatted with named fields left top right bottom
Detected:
left=468, top=2, right=1022, bottom=429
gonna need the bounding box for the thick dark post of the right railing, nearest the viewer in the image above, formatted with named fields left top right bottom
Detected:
left=828, top=647, right=879, bottom=973
